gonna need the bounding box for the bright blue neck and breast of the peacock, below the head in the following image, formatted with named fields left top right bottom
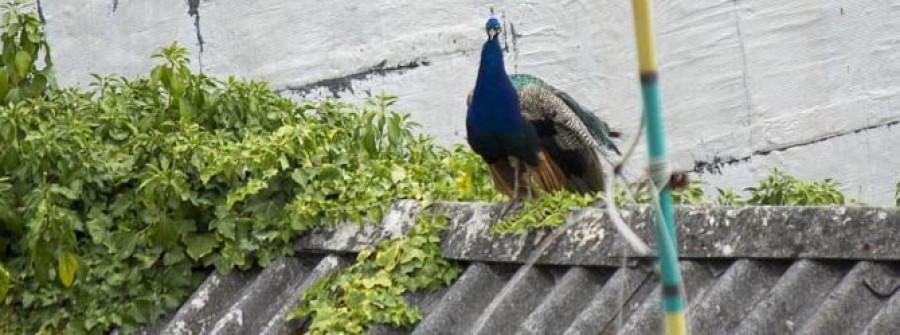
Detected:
left=466, top=39, right=522, bottom=132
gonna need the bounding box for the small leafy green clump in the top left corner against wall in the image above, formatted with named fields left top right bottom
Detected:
left=0, top=0, right=56, bottom=103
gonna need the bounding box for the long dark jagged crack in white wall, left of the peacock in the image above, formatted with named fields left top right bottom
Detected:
left=278, top=59, right=431, bottom=97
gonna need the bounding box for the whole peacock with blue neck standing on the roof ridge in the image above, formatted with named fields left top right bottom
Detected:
left=466, top=16, right=619, bottom=205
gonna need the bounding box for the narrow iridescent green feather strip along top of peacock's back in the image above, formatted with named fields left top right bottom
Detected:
left=509, top=74, right=621, bottom=154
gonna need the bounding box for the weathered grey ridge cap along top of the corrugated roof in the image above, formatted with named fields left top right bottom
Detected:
left=295, top=200, right=900, bottom=266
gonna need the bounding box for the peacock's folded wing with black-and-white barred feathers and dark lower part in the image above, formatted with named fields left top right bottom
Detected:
left=519, top=79, right=603, bottom=192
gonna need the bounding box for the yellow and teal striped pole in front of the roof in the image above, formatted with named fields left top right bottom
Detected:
left=632, top=0, right=687, bottom=335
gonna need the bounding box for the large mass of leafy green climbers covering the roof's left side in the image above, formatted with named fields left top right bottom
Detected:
left=0, top=38, right=497, bottom=333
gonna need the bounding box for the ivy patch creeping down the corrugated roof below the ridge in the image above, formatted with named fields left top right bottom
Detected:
left=288, top=215, right=460, bottom=334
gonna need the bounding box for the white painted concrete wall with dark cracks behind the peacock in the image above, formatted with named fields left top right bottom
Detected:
left=41, top=0, right=900, bottom=205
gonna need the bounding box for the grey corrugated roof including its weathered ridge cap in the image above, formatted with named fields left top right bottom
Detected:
left=134, top=202, right=900, bottom=334
